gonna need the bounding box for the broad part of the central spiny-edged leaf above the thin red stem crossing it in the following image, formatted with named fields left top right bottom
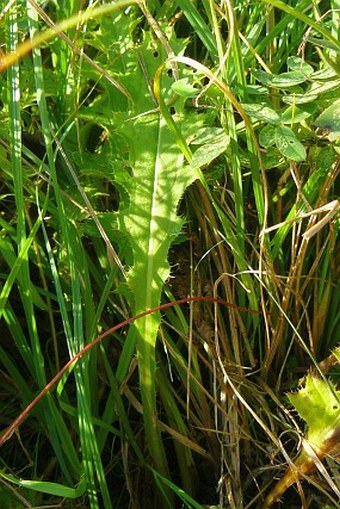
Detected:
left=120, top=114, right=196, bottom=314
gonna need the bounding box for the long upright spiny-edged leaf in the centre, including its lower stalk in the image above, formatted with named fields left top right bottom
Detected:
left=117, top=113, right=197, bottom=484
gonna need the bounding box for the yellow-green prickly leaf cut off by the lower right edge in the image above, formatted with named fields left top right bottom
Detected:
left=288, top=374, right=340, bottom=450
